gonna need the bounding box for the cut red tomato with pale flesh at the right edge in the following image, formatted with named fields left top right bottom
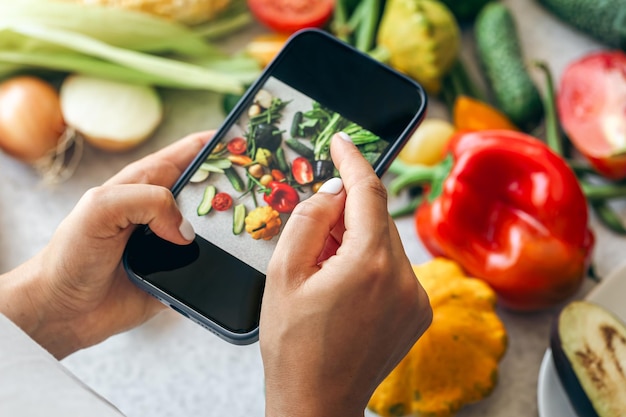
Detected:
left=557, top=50, right=626, bottom=180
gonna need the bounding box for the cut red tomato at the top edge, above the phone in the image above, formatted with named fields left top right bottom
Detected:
left=248, top=0, right=335, bottom=33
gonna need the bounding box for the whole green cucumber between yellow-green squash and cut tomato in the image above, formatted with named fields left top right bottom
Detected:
left=474, top=2, right=543, bottom=132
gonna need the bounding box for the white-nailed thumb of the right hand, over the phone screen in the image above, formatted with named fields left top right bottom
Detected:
left=267, top=178, right=346, bottom=282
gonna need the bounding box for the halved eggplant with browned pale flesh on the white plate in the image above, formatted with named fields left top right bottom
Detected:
left=550, top=301, right=626, bottom=417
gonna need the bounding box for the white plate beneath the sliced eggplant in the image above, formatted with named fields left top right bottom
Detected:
left=537, top=265, right=626, bottom=417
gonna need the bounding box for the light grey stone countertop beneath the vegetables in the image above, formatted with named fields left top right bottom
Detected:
left=0, top=0, right=626, bottom=417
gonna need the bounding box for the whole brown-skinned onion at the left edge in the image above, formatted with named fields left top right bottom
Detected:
left=0, top=76, right=65, bottom=165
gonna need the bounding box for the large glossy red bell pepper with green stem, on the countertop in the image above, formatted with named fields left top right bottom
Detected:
left=390, top=130, right=594, bottom=311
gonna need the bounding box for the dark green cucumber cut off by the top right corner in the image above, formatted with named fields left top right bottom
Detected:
left=539, top=0, right=626, bottom=51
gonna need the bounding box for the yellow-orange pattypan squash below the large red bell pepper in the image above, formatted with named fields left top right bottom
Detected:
left=368, top=258, right=508, bottom=417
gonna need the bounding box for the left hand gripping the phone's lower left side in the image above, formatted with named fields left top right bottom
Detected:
left=0, top=132, right=212, bottom=358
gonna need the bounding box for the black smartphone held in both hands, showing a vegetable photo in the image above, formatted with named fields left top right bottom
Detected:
left=124, top=29, right=427, bottom=344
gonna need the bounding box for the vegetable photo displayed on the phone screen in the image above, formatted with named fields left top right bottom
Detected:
left=177, top=78, right=388, bottom=273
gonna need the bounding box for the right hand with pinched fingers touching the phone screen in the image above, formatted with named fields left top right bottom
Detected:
left=260, top=134, right=432, bottom=417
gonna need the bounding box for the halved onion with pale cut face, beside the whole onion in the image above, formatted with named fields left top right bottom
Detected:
left=60, top=74, right=163, bottom=152
